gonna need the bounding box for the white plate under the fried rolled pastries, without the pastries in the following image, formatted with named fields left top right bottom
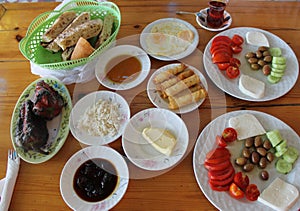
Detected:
left=147, top=63, right=208, bottom=114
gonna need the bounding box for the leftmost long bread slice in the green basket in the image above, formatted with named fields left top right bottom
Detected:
left=42, top=11, right=76, bottom=42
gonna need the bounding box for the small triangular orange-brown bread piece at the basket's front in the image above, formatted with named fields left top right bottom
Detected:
left=71, top=37, right=95, bottom=60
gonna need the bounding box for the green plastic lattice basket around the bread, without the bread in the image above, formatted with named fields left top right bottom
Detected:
left=19, top=0, right=121, bottom=70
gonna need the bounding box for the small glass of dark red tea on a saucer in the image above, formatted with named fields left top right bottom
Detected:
left=207, top=1, right=226, bottom=28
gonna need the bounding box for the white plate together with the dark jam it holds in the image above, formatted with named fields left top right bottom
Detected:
left=60, top=146, right=129, bottom=210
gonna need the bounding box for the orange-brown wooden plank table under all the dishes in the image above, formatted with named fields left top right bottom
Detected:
left=0, top=0, right=300, bottom=211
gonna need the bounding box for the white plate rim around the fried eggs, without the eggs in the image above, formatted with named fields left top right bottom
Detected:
left=140, top=18, right=199, bottom=61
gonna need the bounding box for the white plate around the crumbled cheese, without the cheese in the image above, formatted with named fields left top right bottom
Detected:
left=70, top=91, right=130, bottom=145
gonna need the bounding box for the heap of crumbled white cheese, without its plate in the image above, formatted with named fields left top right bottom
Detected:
left=77, top=99, right=122, bottom=137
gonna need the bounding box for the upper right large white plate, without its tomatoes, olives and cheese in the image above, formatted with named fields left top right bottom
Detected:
left=203, top=27, right=299, bottom=102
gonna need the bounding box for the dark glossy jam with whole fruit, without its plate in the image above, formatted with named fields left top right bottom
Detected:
left=73, top=158, right=119, bottom=202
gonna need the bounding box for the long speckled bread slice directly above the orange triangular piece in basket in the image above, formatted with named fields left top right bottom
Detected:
left=55, top=19, right=103, bottom=50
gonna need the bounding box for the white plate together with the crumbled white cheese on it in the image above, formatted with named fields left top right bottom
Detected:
left=70, top=91, right=130, bottom=145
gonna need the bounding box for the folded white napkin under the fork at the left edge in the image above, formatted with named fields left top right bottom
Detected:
left=0, top=153, right=20, bottom=211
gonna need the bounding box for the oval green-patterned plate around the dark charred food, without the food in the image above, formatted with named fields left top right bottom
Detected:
left=10, top=77, right=72, bottom=164
